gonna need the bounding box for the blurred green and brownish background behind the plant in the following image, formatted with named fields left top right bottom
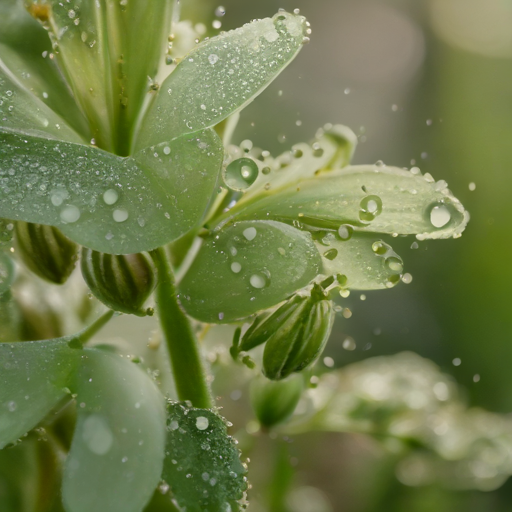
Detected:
left=185, top=0, right=512, bottom=512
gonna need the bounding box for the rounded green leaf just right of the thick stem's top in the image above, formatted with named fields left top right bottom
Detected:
left=179, top=221, right=321, bottom=323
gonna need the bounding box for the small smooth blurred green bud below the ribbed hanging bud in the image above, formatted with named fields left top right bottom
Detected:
left=250, top=375, right=304, bottom=428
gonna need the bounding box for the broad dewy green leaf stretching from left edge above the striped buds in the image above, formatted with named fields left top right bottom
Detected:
left=0, top=130, right=223, bottom=254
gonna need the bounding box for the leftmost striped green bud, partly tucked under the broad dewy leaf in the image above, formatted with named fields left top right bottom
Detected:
left=14, top=221, right=78, bottom=284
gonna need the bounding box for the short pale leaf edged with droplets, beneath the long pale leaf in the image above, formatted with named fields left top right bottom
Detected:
left=315, top=233, right=403, bottom=290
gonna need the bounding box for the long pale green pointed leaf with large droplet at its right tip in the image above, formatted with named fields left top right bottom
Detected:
left=222, top=165, right=469, bottom=239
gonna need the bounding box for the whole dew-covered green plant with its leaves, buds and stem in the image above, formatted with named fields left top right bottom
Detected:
left=0, top=0, right=468, bottom=512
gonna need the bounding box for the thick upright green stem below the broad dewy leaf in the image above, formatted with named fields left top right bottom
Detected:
left=151, top=247, right=213, bottom=409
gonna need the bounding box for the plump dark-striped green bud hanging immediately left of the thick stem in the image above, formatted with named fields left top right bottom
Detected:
left=81, top=247, right=156, bottom=316
